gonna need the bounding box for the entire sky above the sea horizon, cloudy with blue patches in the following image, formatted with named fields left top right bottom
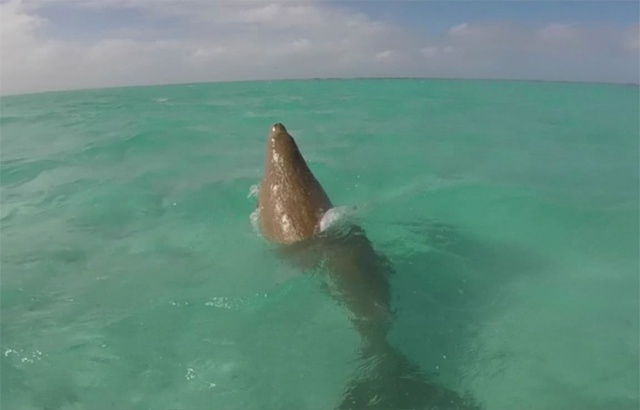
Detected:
left=0, top=0, right=640, bottom=95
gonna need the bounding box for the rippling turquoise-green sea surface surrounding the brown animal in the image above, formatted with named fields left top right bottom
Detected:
left=0, top=80, right=640, bottom=410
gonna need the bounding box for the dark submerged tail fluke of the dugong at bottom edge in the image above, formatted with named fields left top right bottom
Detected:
left=338, top=343, right=480, bottom=410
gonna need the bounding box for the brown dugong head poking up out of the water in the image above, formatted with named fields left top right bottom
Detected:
left=258, top=123, right=332, bottom=244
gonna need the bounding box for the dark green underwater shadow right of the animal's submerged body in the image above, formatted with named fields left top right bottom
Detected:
left=368, top=219, right=548, bottom=408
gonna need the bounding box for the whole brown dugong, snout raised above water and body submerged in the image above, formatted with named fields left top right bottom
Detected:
left=258, top=123, right=478, bottom=409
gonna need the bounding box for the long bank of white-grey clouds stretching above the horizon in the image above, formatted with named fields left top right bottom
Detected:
left=0, top=0, right=638, bottom=94
